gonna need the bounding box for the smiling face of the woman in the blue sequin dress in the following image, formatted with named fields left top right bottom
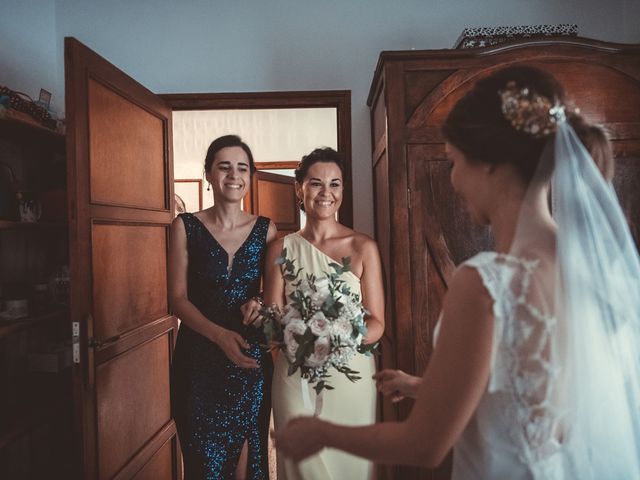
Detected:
left=206, top=147, right=251, bottom=202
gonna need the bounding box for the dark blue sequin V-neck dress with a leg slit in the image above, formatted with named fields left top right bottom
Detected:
left=171, top=213, right=273, bottom=480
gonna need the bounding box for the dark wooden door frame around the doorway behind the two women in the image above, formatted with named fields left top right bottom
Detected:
left=158, top=90, right=353, bottom=228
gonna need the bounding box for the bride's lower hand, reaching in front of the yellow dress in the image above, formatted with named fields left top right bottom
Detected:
left=271, top=417, right=324, bottom=462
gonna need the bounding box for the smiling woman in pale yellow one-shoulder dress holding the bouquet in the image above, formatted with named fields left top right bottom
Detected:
left=264, top=148, right=384, bottom=480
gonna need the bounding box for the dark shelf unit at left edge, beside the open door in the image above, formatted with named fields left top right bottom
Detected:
left=0, top=114, right=72, bottom=478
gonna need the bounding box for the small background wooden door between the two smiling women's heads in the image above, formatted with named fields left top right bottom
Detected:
left=248, top=170, right=300, bottom=237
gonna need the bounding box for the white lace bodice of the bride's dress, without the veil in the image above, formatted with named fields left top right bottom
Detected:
left=453, top=252, right=564, bottom=479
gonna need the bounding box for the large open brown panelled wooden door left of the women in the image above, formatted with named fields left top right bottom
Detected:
left=65, top=38, right=179, bottom=479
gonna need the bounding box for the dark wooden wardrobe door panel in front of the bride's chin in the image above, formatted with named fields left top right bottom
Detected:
left=407, top=144, right=493, bottom=372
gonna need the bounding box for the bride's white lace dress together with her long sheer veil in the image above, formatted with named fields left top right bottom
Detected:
left=444, top=111, right=640, bottom=480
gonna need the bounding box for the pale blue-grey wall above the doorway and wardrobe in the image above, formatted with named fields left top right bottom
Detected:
left=0, top=0, right=640, bottom=233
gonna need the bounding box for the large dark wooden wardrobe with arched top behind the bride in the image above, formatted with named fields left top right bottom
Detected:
left=368, top=37, right=640, bottom=480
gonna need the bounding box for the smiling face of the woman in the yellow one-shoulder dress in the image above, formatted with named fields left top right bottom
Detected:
left=296, top=162, right=344, bottom=219
